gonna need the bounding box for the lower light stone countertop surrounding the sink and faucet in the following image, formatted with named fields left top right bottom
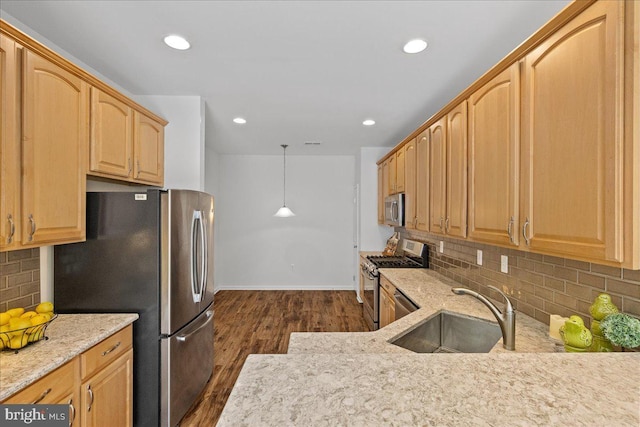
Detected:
left=288, top=268, right=562, bottom=354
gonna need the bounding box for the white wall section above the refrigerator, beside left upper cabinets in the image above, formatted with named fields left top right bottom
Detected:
left=136, top=96, right=205, bottom=191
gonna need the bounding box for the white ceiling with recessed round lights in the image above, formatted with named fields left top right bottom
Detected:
left=0, top=0, right=568, bottom=155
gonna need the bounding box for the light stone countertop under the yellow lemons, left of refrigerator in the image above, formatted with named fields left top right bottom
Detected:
left=0, top=313, right=138, bottom=401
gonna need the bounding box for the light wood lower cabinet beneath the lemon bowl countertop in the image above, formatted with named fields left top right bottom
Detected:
left=2, top=325, right=133, bottom=427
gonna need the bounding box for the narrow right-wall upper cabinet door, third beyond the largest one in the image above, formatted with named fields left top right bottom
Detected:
left=429, top=116, right=447, bottom=233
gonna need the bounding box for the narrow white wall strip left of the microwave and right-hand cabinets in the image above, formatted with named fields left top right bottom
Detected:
left=358, top=147, right=393, bottom=251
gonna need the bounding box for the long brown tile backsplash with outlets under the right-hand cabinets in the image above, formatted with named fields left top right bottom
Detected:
left=396, top=228, right=640, bottom=325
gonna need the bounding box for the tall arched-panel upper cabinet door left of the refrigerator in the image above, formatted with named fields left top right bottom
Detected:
left=22, top=51, right=89, bottom=245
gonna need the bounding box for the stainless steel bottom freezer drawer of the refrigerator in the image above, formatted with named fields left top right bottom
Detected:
left=160, top=304, right=213, bottom=426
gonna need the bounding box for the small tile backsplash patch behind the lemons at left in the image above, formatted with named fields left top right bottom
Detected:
left=0, top=248, right=40, bottom=312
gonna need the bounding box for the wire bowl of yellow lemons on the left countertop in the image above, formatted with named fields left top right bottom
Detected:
left=0, top=301, right=58, bottom=353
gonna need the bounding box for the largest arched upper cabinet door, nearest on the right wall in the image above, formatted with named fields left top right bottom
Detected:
left=521, top=1, right=625, bottom=262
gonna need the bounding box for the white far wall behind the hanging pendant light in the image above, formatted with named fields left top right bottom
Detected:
left=216, top=155, right=355, bottom=290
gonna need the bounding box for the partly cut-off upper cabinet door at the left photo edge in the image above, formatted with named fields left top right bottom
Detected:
left=0, top=35, right=21, bottom=250
